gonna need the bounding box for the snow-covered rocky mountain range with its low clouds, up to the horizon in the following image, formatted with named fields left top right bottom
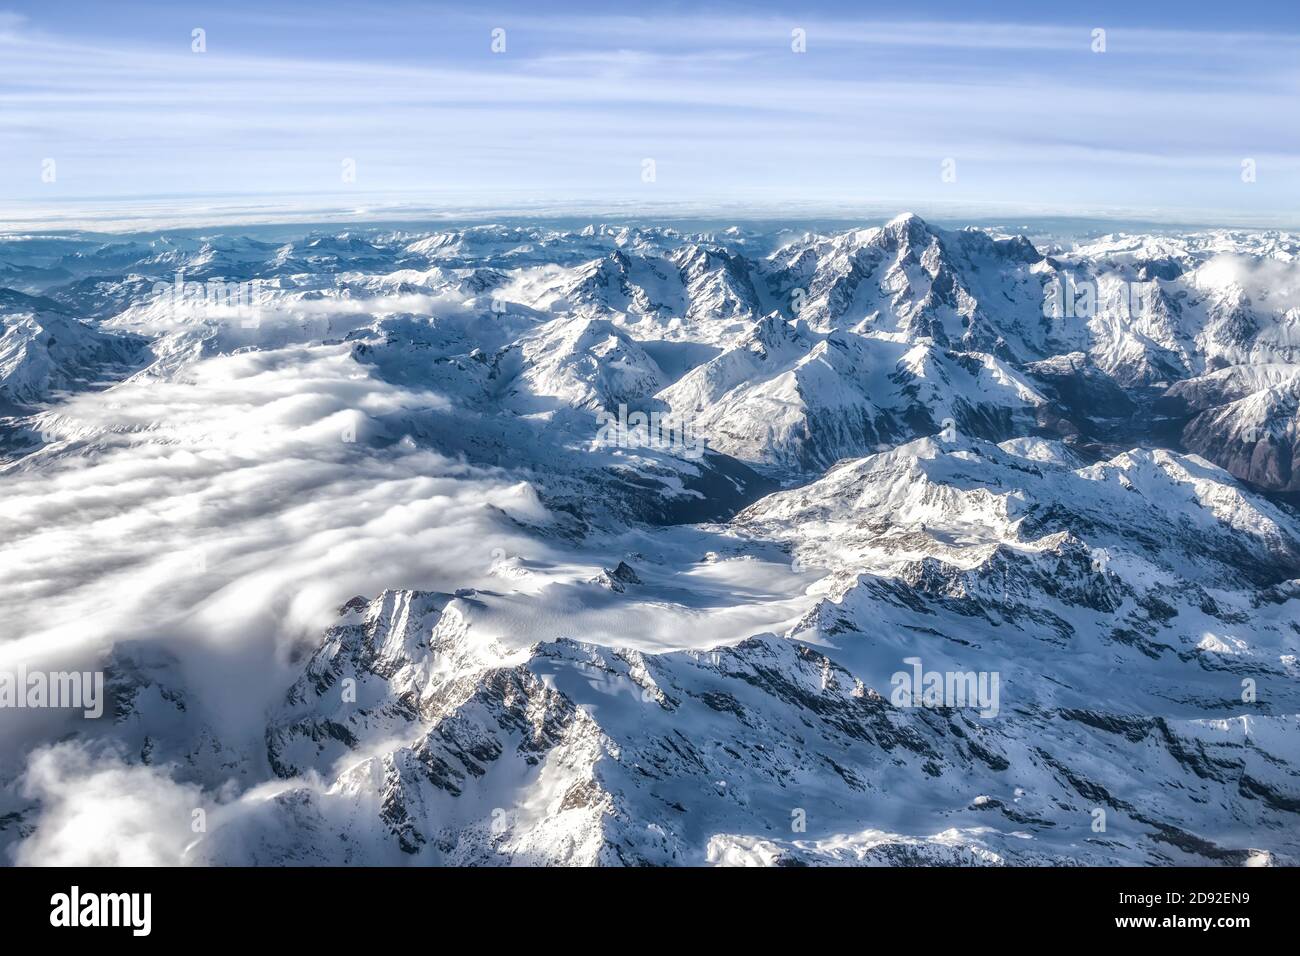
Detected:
left=0, top=215, right=1300, bottom=865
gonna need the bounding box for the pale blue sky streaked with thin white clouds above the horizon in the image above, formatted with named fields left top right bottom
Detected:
left=0, top=0, right=1300, bottom=225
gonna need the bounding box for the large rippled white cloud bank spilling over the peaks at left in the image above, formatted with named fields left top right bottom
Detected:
left=0, top=335, right=549, bottom=710
